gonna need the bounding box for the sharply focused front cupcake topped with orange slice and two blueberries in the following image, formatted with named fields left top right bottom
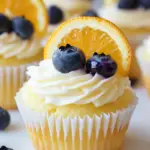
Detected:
left=16, top=17, right=136, bottom=150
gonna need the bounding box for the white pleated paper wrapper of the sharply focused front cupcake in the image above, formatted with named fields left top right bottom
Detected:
left=17, top=99, right=136, bottom=150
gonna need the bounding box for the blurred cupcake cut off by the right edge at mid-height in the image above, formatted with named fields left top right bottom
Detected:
left=136, top=37, right=150, bottom=94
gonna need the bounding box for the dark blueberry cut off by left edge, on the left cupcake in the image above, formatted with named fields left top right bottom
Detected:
left=0, top=13, right=12, bottom=34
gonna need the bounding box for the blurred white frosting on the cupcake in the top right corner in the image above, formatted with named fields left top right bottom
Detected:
left=99, top=5, right=150, bottom=28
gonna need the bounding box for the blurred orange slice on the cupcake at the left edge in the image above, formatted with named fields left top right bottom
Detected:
left=0, top=0, right=48, bottom=36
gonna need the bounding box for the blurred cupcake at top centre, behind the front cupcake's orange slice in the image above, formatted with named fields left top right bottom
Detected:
left=42, top=0, right=93, bottom=46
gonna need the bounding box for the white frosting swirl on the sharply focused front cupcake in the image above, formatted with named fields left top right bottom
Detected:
left=28, top=60, right=130, bottom=107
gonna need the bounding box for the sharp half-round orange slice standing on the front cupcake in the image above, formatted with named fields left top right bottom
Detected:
left=44, top=17, right=131, bottom=76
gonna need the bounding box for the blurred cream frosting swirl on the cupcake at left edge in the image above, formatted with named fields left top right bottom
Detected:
left=0, top=33, right=41, bottom=59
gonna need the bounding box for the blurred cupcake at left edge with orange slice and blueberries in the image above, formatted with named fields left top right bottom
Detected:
left=0, top=0, right=47, bottom=109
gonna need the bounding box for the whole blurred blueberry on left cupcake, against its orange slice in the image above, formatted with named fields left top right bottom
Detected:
left=12, top=17, right=34, bottom=40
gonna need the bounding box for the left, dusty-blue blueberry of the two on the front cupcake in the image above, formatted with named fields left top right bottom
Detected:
left=52, top=44, right=86, bottom=73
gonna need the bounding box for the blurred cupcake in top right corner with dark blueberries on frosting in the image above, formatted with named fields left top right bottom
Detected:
left=99, top=0, right=150, bottom=79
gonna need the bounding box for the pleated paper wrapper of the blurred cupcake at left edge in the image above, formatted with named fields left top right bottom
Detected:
left=0, top=63, right=37, bottom=109
